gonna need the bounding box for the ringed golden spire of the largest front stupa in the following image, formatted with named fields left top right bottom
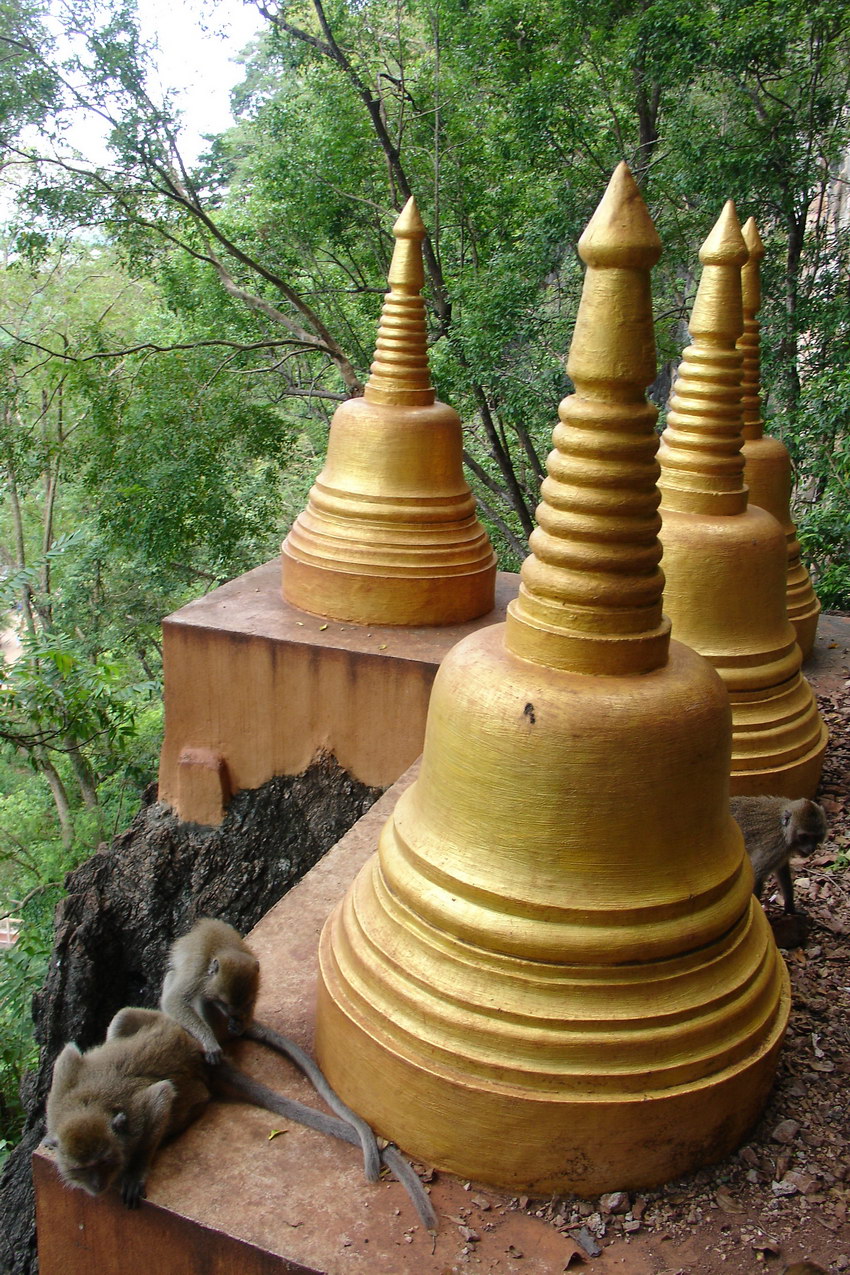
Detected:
left=506, top=163, right=669, bottom=673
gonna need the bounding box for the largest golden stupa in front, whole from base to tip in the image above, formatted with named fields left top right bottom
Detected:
left=316, top=164, right=789, bottom=1195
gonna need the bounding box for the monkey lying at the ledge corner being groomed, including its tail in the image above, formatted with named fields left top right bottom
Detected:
left=45, top=1009, right=437, bottom=1232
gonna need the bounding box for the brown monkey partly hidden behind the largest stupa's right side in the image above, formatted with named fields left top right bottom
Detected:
left=730, top=797, right=826, bottom=913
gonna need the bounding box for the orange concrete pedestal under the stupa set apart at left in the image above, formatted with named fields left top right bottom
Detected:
left=159, top=558, right=519, bottom=825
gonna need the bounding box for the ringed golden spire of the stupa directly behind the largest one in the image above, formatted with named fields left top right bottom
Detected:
left=659, top=199, right=749, bottom=514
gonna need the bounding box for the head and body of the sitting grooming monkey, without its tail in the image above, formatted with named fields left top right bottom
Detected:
left=159, top=917, right=260, bottom=1063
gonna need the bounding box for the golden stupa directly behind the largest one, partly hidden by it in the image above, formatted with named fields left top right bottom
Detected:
left=659, top=200, right=827, bottom=797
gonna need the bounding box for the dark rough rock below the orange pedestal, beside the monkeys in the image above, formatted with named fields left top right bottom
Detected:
left=0, top=757, right=382, bottom=1275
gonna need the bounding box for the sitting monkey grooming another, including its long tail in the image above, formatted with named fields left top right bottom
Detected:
left=159, top=917, right=381, bottom=1182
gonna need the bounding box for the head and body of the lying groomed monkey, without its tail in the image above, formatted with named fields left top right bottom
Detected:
left=47, top=1010, right=210, bottom=1209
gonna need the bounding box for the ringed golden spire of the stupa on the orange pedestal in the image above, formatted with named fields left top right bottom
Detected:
left=364, top=195, right=436, bottom=407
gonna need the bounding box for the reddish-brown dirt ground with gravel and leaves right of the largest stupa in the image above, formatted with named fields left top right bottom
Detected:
left=433, top=627, right=850, bottom=1275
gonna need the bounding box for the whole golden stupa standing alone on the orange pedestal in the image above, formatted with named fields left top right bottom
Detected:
left=282, top=199, right=496, bottom=625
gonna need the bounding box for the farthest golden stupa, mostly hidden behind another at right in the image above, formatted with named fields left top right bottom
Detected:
left=738, top=217, right=821, bottom=659
